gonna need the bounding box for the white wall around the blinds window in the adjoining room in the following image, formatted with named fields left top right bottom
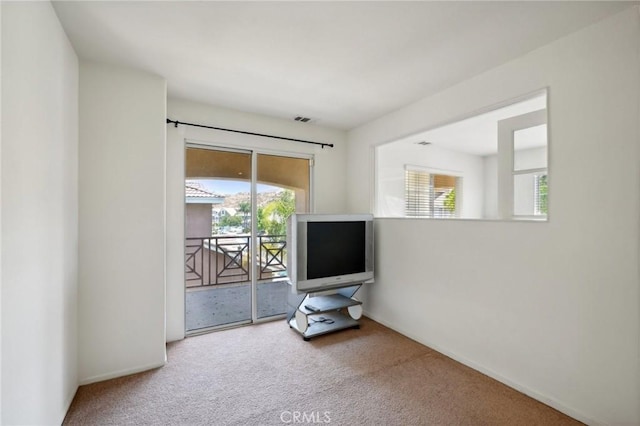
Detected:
left=375, top=144, right=484, bottom=219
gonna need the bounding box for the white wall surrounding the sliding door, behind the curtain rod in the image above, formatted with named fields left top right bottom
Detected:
left=167, top=99, right=344, bottom=341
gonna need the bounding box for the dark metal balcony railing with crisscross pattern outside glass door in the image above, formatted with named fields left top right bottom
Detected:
left=185, top=235, right=287, bottom=287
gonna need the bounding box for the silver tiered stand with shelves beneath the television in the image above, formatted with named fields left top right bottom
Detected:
left=287, top=284, right=362, bottom=341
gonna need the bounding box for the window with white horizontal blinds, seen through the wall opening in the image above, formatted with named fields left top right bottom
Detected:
left=405, top=169, right=461, bottom=218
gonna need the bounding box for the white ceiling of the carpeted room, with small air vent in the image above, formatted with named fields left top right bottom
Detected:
left=54, top=1, right=637, bottom=129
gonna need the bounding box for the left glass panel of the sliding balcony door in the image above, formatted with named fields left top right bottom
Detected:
left=185, top=148, right=253, bottom=333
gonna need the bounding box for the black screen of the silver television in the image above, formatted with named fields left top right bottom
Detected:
left=307, top=221, right=366, bottom=280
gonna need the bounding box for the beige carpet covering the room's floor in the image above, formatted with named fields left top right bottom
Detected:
left=64, top=318, right=579, bottom=425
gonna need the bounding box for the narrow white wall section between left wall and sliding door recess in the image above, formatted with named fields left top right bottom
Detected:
left=79, top=61, right=166, bottom=383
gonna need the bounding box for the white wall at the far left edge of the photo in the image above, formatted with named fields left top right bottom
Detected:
left=0, top=2, right=78, bottom=424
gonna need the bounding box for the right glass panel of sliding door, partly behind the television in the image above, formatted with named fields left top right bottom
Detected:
left=255, top=154, right=310, bottom=319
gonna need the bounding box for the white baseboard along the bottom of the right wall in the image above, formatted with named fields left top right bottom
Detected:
left=364, top=311, right=607, bottom=426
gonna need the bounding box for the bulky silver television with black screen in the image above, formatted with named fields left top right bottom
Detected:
left=287, top=214, right=374, bottom=293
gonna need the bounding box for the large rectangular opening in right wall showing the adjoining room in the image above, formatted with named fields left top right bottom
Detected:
left=375, top=90, right=550, bottom=221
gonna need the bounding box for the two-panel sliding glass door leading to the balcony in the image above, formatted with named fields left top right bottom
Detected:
left=185, top=146, right=310, bottom=333
